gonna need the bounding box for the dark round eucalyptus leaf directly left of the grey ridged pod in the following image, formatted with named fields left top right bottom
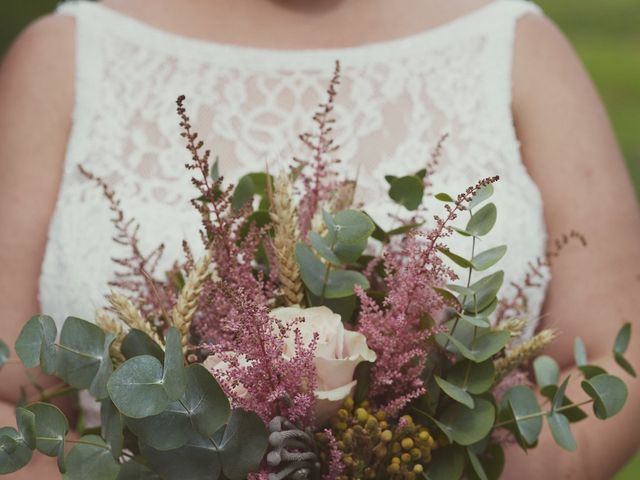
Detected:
left=219, top=409, right=269, bottom=480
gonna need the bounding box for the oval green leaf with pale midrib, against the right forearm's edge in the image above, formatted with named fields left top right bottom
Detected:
left=501, top=385, right=542, bottom=446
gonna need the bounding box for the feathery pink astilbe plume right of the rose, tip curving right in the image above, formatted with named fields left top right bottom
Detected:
left=356, top=178, right=497, bottom=415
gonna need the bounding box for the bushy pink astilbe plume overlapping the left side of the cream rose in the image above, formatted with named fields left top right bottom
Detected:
left=207, top=289, right=318, bottom=426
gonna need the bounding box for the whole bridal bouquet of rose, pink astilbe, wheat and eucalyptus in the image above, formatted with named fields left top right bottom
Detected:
left=0, top=64, right=635, bottom=480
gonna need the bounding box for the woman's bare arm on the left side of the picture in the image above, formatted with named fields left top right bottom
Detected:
left=0, top=16, right=74, bottom=480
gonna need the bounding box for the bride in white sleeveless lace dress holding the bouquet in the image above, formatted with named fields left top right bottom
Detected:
left=0, top=0, right=640, bottom=479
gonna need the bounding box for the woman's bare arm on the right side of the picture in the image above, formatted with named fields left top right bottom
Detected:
left=505, top=13, right=640, bottom=480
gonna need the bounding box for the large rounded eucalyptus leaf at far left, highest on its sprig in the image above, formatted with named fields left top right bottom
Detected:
left=15, top=315, right=58, bottom=374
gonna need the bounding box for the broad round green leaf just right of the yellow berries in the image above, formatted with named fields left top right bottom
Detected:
left=437, top=398, right=496, bottom=446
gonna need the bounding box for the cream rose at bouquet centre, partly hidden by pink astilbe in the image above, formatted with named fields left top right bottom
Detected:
left=205, top=307, right=376, bottom=424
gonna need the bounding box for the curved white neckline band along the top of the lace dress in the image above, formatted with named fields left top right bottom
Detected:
left=60, top=0, right=527, bottom=68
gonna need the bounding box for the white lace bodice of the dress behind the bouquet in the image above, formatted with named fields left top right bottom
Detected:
left=40, top=0, right=546, bottom=342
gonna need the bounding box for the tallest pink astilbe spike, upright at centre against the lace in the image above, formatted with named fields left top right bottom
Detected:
left=293, top=62, right=340, bottom=239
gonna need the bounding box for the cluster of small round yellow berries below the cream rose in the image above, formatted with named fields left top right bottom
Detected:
left=324, top=398, right=437, bottom=480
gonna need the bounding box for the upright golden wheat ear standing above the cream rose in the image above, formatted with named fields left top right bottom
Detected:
left=271, top=173, right=304, bottom=305
